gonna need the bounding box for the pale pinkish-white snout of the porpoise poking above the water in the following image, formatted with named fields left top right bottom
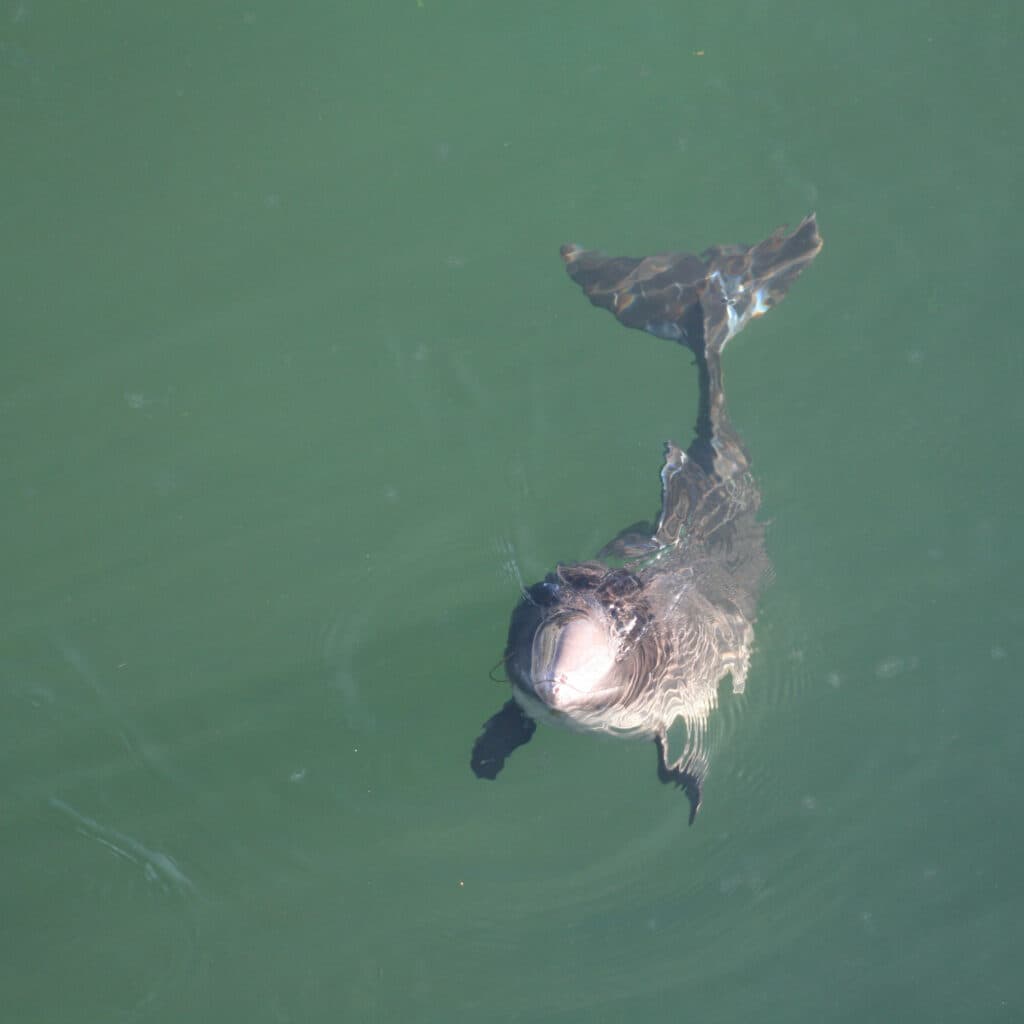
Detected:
left=529, top=611, right=615, bottom=711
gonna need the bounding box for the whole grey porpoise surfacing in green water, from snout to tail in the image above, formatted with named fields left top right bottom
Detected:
left=471, top=215, right=821, bottom=822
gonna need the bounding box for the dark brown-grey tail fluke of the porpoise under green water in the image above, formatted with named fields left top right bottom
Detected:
left=561, top=213, right=821, bottom=352
